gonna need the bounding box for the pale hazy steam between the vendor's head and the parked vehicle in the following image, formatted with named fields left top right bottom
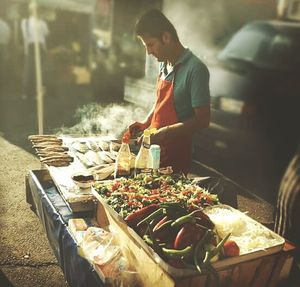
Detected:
left=163, top=0, right=276, bottom=59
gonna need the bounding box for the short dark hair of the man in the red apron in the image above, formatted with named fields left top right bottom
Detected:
left=135, top=9, right=179, bottom=41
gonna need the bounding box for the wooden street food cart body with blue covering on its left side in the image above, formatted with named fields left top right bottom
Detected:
left=26, top=136, right=293, bottom=287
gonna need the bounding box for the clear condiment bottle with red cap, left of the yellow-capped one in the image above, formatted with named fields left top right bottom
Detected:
left=114, top=133, right=131, bottom=178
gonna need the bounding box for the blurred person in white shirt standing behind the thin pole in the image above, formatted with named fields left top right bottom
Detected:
left=21, top=3, right=49, bottom=99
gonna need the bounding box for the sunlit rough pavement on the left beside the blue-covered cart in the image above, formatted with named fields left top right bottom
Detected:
left=0, top=137, right=67, bottom=287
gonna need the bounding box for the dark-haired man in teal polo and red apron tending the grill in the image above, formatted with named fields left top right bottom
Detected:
left=129, top=10, right=210, bottom=173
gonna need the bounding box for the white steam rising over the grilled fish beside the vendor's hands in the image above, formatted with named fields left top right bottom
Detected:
left=57, top=103, right=147, bottom=138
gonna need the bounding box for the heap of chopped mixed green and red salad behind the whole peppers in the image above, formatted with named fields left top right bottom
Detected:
left=94, top=174, right=219, bottom=218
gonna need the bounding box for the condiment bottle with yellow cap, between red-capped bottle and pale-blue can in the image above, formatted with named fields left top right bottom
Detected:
left=134, top=129, right=151, bottom=175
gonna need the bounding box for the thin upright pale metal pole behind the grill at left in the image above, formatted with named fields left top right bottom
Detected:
left=32, top=0, right=44, bottom=134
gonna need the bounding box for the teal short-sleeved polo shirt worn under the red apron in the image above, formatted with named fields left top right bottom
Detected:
left=160, top=49, right=210, bottom=121
